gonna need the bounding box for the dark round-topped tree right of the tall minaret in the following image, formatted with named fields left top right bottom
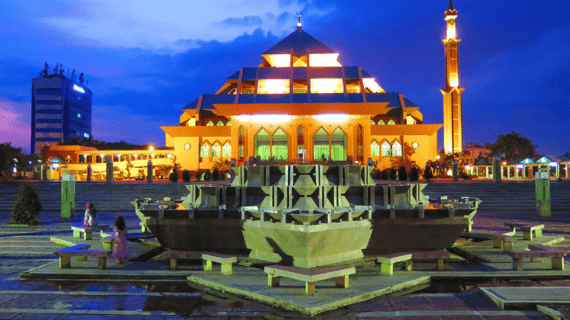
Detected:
left=485, top=131, right=538, bottom=160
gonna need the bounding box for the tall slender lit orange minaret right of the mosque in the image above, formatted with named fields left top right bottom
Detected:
left=441, top=0, right=465, bottom=154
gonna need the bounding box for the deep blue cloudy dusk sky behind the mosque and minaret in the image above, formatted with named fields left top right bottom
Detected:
left=0, top=0, right=570, bottom=156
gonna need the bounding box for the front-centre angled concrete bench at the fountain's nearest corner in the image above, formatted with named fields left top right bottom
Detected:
left=263, top=264, right=356, bottom=295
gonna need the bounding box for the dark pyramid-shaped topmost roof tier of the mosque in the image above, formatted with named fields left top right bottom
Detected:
left=262, top=29, right=337, bottom=55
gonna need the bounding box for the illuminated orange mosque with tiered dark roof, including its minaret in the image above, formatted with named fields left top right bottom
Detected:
left=161, top=0, right=464, bottom=170
